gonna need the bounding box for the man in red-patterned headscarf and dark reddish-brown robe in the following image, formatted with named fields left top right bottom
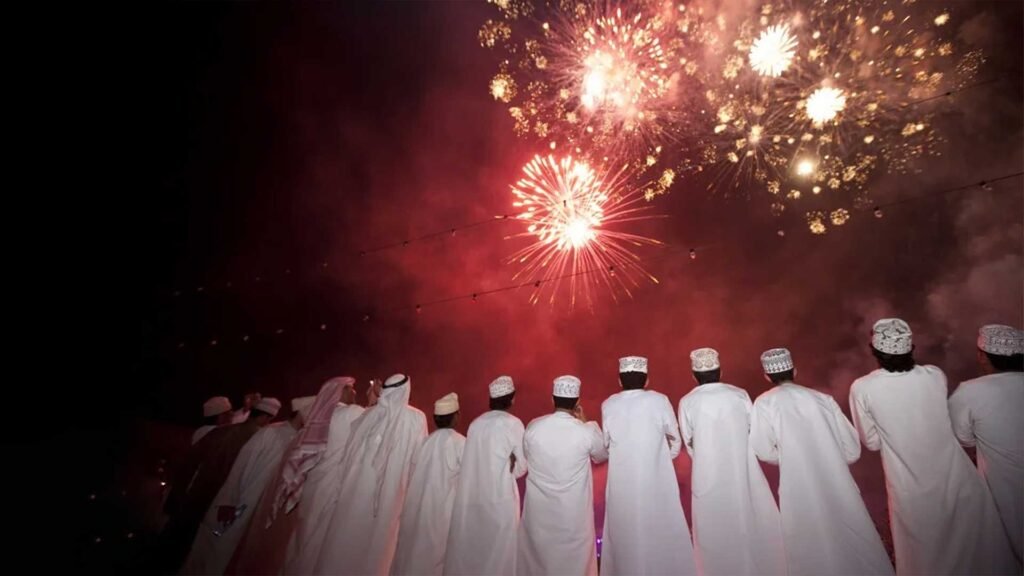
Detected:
left=226, top=376, right=355, bottom=576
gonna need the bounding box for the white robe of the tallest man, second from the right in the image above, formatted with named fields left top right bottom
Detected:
left=850, top=366, right=1014, bottom=576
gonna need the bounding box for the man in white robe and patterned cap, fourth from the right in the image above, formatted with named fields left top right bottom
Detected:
left=679, top=348, right=785, bottom=576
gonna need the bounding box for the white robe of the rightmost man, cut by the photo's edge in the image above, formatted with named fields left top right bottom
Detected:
left=949, top=372, right=1024, bottom=562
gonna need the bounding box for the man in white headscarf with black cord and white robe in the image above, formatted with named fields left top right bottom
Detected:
left=313, top=374, right=427, bottom=576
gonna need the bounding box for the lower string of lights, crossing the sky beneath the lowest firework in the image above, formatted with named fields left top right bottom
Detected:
left=163, top=170, right=1024, bottom=351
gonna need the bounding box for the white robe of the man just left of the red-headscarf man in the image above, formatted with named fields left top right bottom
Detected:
left=181, top=422, right=298, bottom=575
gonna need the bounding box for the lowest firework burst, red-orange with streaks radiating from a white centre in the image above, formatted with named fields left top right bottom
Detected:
left=511, top=156, right=660, bottom=305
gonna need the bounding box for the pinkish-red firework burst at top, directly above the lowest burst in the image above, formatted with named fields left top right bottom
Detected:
left=480, top=0, right=699, bottom=161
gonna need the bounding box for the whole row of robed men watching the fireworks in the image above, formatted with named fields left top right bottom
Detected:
left=160, top=319, right=1024, bottom=576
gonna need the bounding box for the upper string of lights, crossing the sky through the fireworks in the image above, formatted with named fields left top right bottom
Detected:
left=168, top=71, right=1020, bottom=297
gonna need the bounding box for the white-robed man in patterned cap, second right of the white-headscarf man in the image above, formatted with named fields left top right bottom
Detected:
left=444, top=376, right=526, bottom=576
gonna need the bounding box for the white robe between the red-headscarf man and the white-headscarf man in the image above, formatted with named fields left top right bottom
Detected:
left=282, top=404, right=365, bottom=574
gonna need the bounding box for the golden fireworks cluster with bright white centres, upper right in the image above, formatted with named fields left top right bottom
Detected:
left=690, top=0, right=983, bottom=234
